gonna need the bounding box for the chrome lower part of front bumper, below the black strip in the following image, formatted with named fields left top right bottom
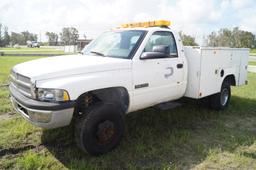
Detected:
left=11, top=96, right=74, bottom=129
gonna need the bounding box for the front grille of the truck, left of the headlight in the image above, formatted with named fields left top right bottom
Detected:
left=10, top=70, right=32, bottom=97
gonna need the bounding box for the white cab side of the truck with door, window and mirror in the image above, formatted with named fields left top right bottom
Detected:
left=116, top=27, right=187, bottom=112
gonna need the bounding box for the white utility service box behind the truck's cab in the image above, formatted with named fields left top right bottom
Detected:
left=184, top=47, right=249, bottom=99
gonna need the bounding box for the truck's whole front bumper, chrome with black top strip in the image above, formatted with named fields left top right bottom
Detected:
left=9, top=86, right=75, bottom=129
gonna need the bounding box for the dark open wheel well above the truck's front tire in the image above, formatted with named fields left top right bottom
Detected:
left=76, top=87, right=130, bottom=113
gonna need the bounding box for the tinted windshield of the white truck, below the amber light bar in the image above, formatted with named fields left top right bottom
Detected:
left=82, top=30, right=145, bottom=59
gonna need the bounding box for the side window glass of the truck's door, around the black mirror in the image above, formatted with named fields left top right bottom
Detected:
left=144, top=31, right=178, bottom=57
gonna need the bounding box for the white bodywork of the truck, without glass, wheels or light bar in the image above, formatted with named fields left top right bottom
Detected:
left=10, top=27, right=249, bottom=128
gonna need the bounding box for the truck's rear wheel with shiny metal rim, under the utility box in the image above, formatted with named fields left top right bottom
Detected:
left=210, top=81, right=231, bottom=110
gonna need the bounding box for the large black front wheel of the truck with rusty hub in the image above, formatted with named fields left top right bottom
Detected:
left=75, top=103, right=124, bottom=155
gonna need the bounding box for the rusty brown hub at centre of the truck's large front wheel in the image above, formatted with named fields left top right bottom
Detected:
left=96, top=120, right=115, bottom=145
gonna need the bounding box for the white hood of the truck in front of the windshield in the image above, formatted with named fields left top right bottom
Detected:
left=13, top=55, right=131, bottom=80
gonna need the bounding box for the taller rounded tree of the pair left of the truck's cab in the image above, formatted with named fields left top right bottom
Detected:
left=60, top=27, right=79, bottom=45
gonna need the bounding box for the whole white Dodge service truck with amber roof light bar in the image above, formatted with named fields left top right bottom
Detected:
left=9, top=20, right=249, bottom=155
